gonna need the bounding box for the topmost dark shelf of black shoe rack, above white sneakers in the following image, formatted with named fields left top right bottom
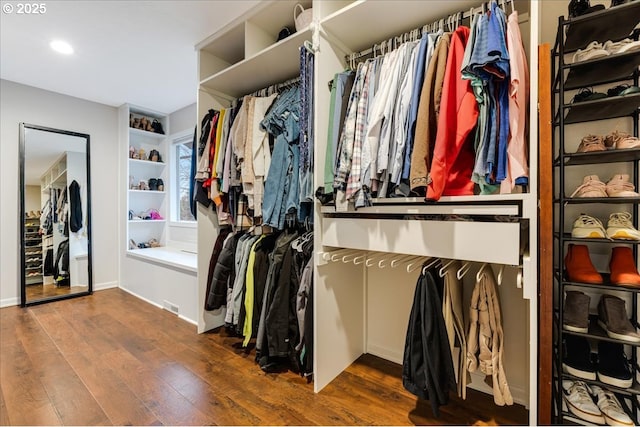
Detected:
left=564, top=1, right=640, bottom=53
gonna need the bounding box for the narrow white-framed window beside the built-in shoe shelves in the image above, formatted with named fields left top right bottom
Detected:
left=171, top=133, right=195, bottom=222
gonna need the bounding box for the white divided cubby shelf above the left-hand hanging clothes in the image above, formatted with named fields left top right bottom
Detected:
left=196, top=0, right=311, bottom=98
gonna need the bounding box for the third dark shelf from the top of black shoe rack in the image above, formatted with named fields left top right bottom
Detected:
left=564, top=93, right=640, bottom=125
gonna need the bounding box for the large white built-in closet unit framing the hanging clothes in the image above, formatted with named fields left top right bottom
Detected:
left=196, top=0, right=540, bottom=425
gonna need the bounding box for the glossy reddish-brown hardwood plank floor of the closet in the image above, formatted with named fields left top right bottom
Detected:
left=0, top=289, right=528, bottom=425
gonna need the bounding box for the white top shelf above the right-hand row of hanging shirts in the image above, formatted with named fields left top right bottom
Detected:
left=320, top=0, right=479, bottom=52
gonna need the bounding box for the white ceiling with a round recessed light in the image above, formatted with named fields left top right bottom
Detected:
left=0, top=0, right=258, bottom=114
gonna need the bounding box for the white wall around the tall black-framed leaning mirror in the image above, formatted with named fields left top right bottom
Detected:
left=0, top=80, right=119, bottom=306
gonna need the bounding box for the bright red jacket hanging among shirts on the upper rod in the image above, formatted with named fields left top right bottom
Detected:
left=427, top=26, right=478, bottom=200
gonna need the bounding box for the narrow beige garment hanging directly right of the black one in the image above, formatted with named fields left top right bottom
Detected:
left=442, top=261, right=469, bottom=399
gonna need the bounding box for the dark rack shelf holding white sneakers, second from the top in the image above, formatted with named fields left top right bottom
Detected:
left=564, top=49, right=640, bottom=90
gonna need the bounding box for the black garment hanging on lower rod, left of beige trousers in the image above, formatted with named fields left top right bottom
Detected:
left=402, top=271, right=464, bottom=417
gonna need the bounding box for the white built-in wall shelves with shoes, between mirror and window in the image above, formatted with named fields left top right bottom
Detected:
left=120, top=104, right=169, bottom=251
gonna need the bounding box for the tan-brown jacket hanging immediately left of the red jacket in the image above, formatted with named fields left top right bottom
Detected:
left=409, top=33, right=451, bottom=190
